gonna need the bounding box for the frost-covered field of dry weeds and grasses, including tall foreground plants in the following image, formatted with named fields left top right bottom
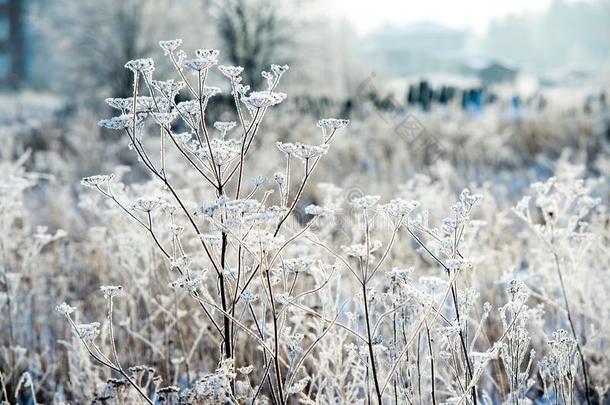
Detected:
left=0, top=41, right=610, bottom=404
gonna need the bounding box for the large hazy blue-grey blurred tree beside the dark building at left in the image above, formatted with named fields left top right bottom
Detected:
left=30, top=0, right=206, bottom=101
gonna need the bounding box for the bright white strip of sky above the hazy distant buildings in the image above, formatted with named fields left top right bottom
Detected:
left=333, top=0, right=552, bottom=34
